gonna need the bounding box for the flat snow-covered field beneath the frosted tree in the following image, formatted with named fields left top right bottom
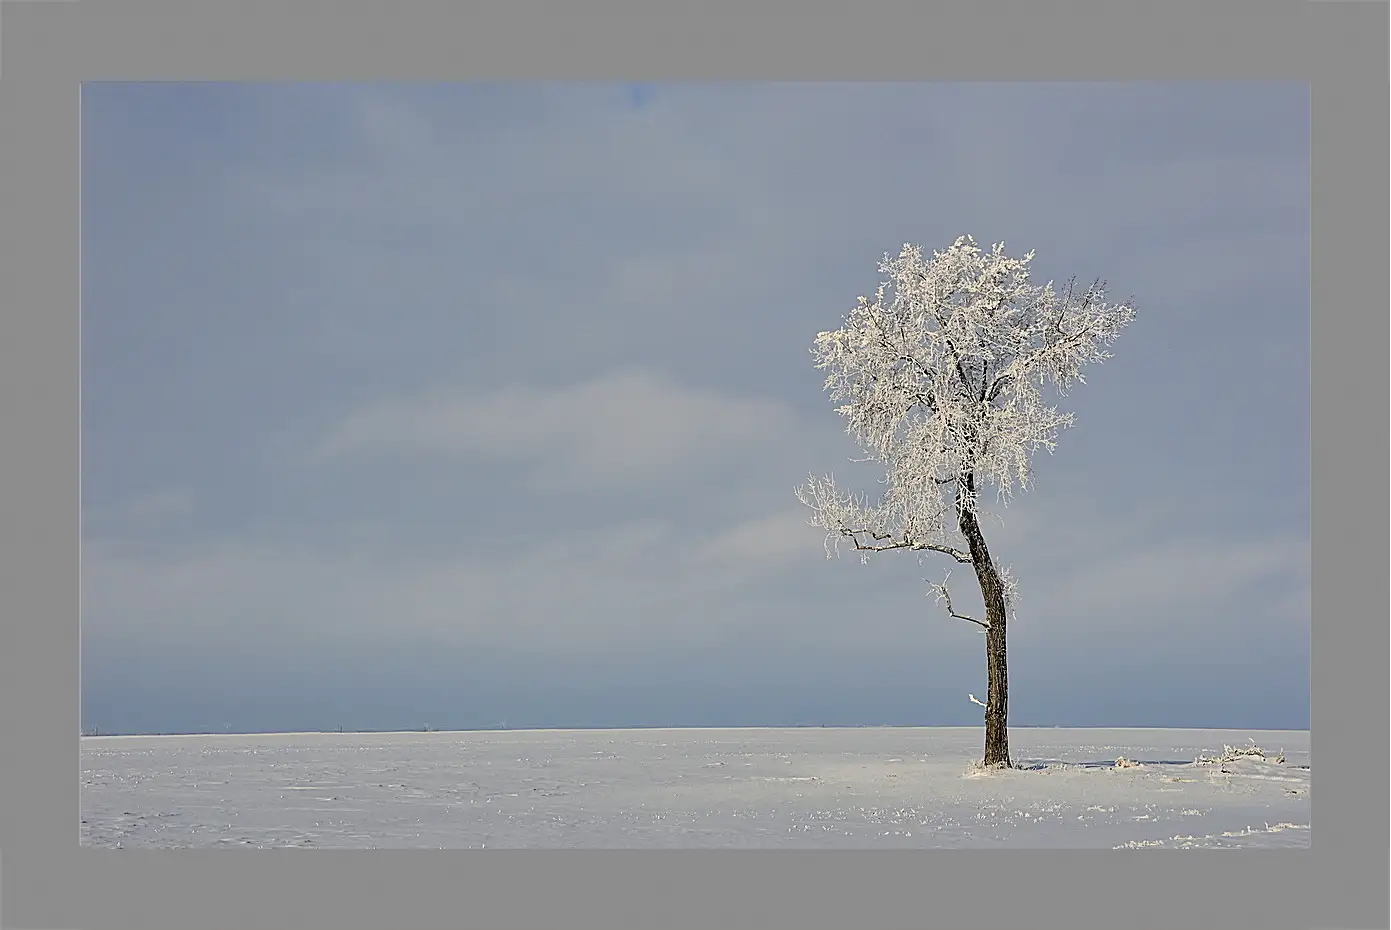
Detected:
left=81, top=727, right=1310, bottom=849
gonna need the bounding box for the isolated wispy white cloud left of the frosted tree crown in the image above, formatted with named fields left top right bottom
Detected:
left=319, top=371, right=797, bottom=489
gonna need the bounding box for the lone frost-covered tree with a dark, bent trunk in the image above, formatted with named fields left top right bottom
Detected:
left=797, top=236, right=1135, bottom=767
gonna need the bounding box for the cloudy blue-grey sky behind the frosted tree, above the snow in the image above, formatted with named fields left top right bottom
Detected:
left=81, top=83, right=1310, bottom=733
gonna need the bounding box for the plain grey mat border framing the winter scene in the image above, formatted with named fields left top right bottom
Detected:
left=0, top=0, right=1388, bottom=930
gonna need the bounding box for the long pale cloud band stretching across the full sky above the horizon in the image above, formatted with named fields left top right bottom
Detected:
left=83, top=509, right=1308, bottom=675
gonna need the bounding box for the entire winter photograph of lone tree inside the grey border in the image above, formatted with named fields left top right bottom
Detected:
left=78, top=82, right=1312, bottom=849
